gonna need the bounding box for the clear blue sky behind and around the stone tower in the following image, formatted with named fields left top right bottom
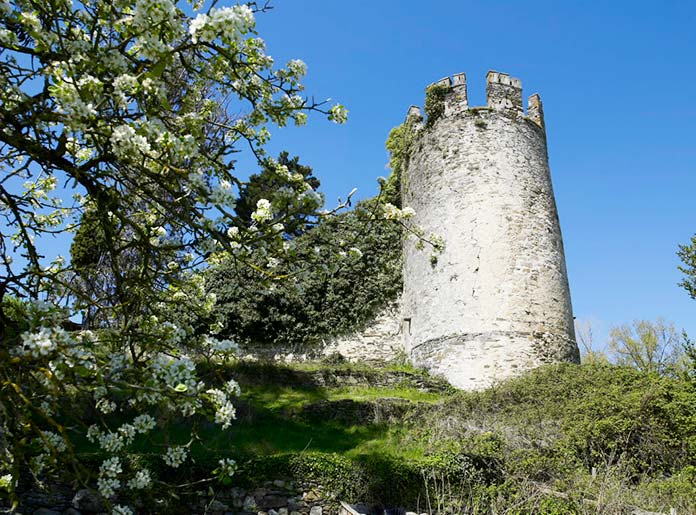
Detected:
left=253, top=0, right=696, bottom=346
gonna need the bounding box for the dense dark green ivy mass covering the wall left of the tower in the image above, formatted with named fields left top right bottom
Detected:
left=206, top=199, right=403, bottom=347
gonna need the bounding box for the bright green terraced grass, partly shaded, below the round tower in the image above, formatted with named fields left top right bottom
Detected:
left=198, top=364, right=451, bottom=457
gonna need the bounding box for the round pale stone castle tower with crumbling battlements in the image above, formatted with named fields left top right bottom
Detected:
left=401, top=72, right=579, bottom=389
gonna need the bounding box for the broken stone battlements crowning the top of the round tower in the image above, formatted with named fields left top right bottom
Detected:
left=407, top=71, right=544, bottom=129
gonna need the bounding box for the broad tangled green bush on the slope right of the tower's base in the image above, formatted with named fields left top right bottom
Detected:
left=430, top=364, right=696, bottom=480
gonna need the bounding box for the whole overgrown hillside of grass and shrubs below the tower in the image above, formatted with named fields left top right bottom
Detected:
left=61, top=363, right=696, bottom=515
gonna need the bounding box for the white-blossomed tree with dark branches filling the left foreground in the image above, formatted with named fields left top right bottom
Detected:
left=0, top=0, right=346, bottom=508
